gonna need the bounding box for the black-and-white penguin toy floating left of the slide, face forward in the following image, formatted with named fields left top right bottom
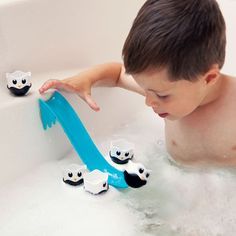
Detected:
left=63, top=164, right=87, bottom=186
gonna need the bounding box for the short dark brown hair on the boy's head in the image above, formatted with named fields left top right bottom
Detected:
left=122, top=0, right=226, bottom=80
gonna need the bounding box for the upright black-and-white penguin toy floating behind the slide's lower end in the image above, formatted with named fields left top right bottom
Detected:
left=109, top=139, right=134, bottom=164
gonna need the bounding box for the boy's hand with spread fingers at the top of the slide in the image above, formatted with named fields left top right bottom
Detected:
left=39, top=77, right=100, bottom=111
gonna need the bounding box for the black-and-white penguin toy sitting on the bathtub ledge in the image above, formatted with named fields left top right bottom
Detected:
left=6, top=71, right=32, bottom=96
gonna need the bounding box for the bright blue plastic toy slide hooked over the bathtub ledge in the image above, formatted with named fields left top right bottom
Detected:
left=39, top=91, right=128, bottom=188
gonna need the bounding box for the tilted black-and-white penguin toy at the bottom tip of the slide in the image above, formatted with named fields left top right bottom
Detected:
left=124, top=161, right=151, bottom=188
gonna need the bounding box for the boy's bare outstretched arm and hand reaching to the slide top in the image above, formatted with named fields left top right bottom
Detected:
left=39, top=63, right=144, bottom=111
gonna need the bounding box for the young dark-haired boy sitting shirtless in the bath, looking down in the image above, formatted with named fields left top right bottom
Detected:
left=39, top=0, right=236, bottom=166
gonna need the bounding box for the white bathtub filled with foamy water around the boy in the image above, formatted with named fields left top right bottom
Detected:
left=0, top=0, right=236, bottom=236
